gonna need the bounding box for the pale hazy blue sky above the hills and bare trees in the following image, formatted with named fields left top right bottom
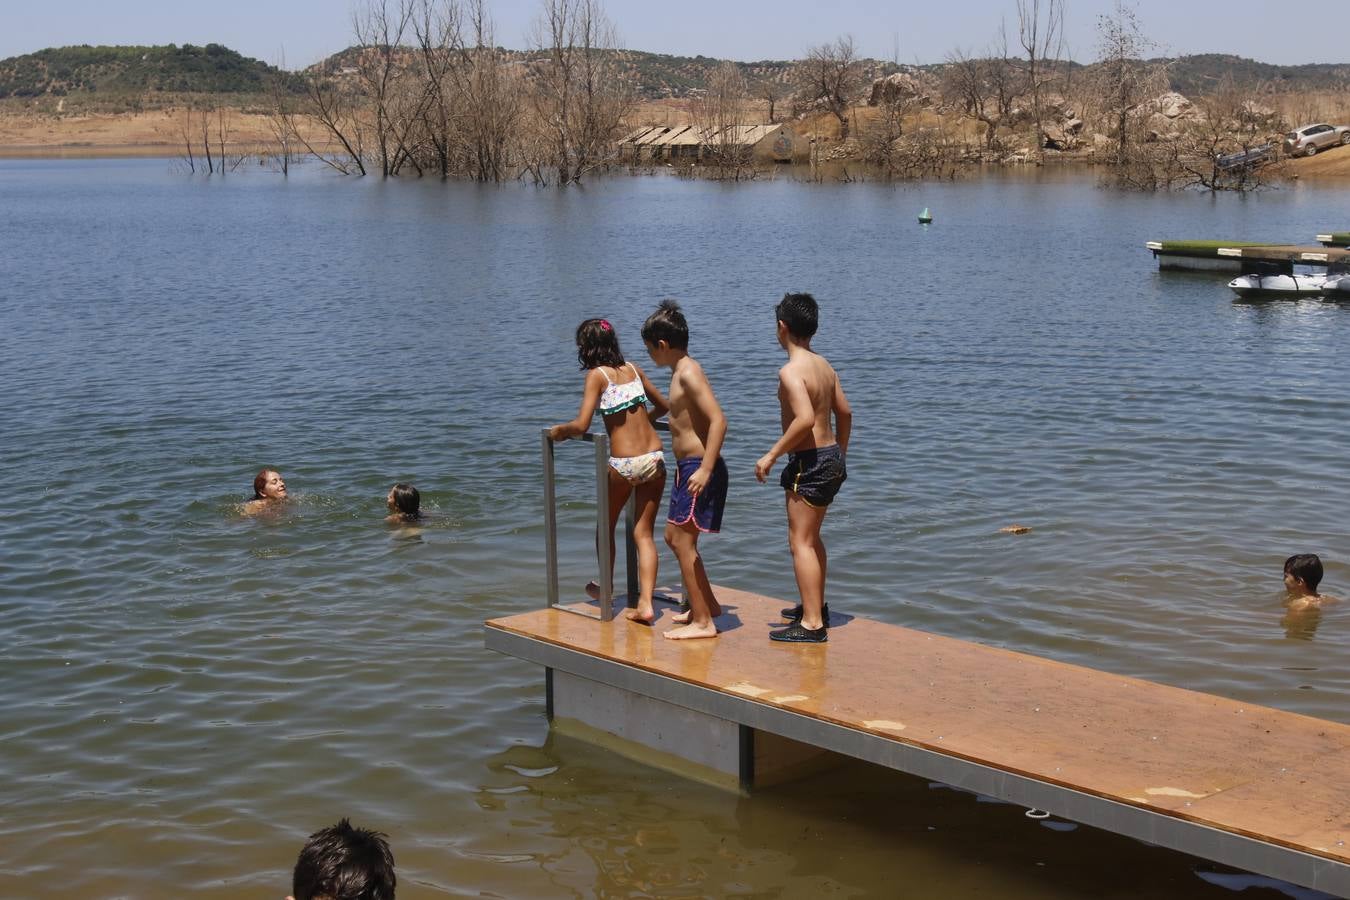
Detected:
left=0, top=0, right=1350, bottom=67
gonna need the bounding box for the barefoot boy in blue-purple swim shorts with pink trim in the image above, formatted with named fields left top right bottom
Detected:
left=643, top=300, right=726, bottom=641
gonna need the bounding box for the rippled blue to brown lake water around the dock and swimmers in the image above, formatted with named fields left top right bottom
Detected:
left=0, top=161, right=1350, bottom=899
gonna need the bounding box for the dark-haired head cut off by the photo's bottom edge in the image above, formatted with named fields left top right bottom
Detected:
left=290, top=819, right=397, bottom=900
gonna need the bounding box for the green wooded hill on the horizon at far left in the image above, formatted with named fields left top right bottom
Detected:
left=0, top=43, right=275, bottom=99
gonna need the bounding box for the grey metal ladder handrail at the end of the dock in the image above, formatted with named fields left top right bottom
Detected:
left=543, top=422, right=670, bottom=622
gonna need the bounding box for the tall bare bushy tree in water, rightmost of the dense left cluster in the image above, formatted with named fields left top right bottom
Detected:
left=531, top=0, right=632, bottom=185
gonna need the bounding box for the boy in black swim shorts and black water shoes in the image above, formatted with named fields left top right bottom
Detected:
left=755, top=294, right=853, bottom=644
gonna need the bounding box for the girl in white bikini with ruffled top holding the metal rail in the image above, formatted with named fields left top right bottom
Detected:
left=548, top=318, right=666, bottom=625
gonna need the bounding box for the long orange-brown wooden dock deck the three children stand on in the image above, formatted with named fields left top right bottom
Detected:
left=485, top=588, right=1350, bottom=896
